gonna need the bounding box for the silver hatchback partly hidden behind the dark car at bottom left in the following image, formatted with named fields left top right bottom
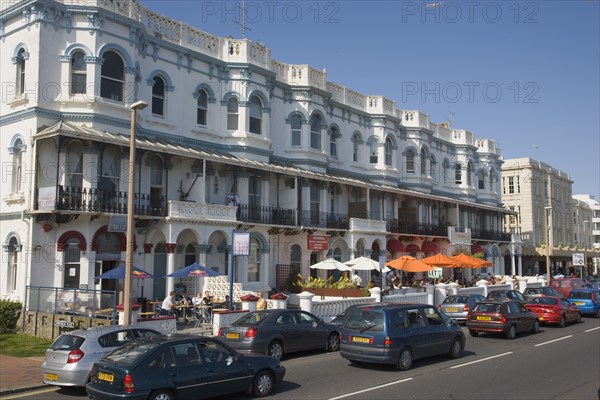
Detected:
left=42, top=325, right=161, bottom=386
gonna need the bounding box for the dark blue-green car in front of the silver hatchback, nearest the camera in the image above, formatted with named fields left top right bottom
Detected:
left=86, top=334, right=285, bottom=400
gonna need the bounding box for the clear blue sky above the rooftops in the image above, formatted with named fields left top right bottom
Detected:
left=142, top=0, right=600, bottom=201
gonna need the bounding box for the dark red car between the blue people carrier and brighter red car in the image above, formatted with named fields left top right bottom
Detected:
left=467, top=300, right=540, bottom=339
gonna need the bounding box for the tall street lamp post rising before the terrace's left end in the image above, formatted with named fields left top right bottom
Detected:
left=123, top=100, right=148, bottom=325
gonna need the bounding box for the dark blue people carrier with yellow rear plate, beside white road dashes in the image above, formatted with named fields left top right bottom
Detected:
left=340, top=304, right=465, bottom=370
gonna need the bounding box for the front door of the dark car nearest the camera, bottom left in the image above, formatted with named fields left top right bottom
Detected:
left=199, top=339, right=253, bottom=397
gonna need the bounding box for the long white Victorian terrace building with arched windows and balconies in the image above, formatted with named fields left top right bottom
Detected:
left=0, top=0, right=510, bottom=300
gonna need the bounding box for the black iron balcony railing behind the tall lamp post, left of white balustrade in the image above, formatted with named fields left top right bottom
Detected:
left=50, top=185, right=166, bottom=216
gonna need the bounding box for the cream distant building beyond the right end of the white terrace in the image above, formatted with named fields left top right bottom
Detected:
left=501, top=158, right=600, bottom=275
